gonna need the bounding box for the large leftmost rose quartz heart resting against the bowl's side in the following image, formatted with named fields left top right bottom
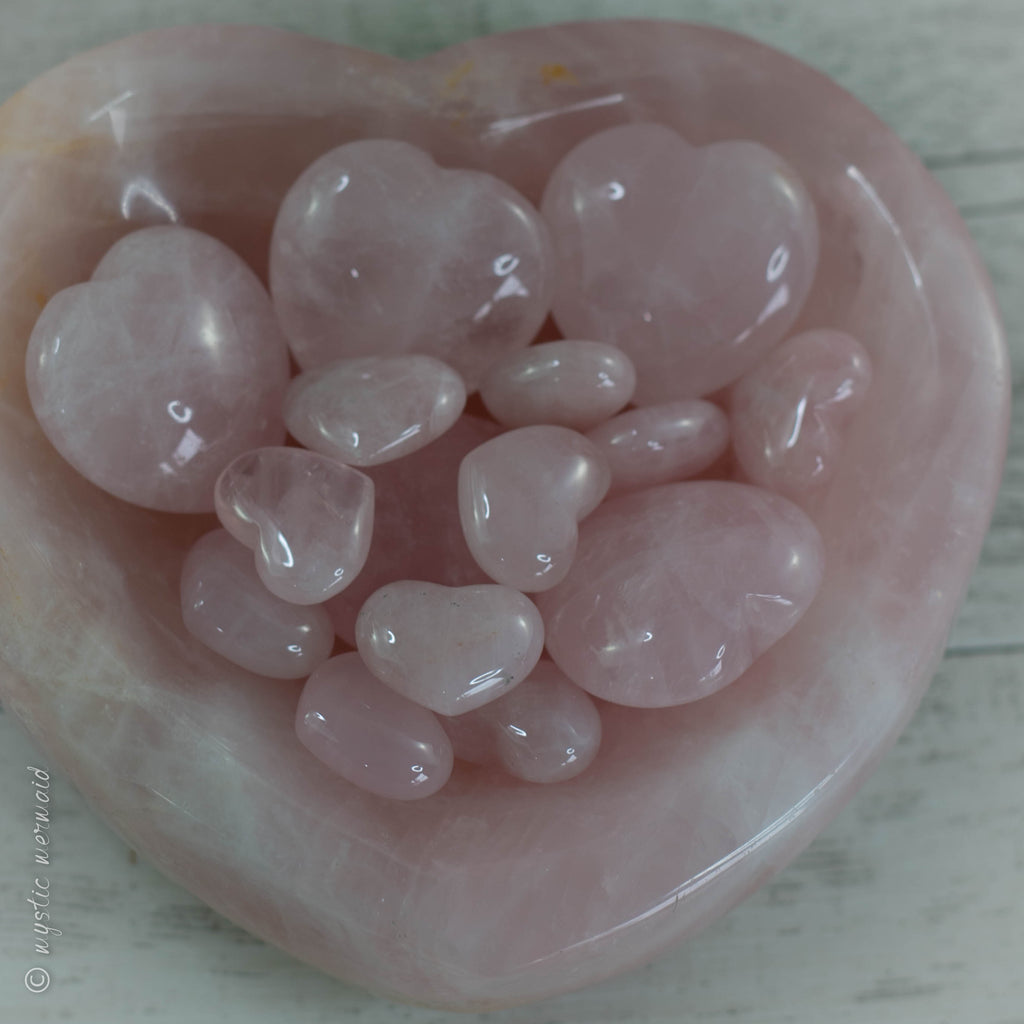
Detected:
left=26, top=227, right=288, bottom=512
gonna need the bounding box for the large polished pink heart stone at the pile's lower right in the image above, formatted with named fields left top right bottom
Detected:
left=538, top=480, right=824, bottom=708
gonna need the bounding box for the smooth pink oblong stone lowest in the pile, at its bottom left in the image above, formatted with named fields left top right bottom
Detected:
left=295, top=651, right=452, bottom=800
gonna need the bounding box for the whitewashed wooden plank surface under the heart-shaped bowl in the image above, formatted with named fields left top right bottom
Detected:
left=0, top=0, right=1024, bottom=1024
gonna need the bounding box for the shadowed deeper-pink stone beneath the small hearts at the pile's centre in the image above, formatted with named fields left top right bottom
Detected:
left=327, top=416, right=498, bottom=644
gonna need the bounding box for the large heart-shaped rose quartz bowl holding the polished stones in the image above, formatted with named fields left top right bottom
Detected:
left=0, top=22, right=1009, bottom=1010
